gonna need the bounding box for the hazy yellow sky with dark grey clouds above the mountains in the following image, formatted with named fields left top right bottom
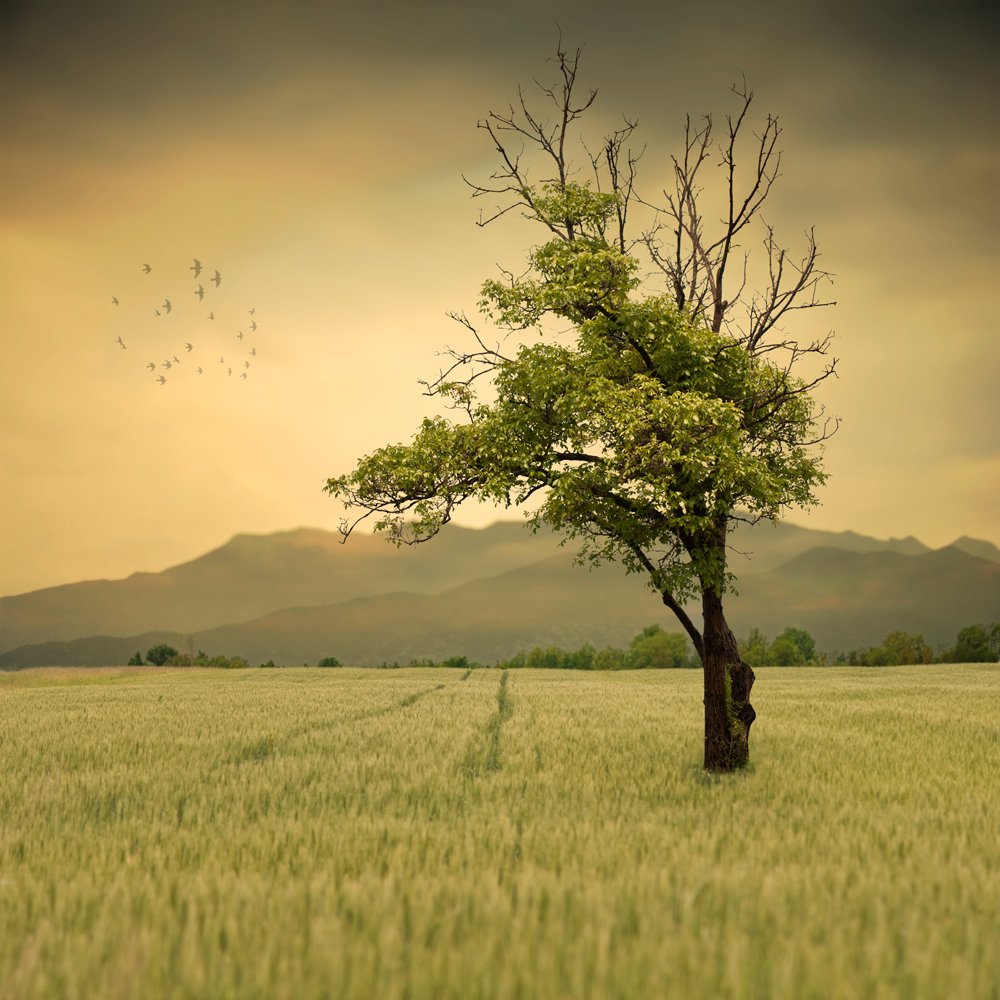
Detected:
left=0, top=0, right=1000, bottom=594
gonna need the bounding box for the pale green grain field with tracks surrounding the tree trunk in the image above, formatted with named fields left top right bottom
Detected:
left=0, top=665, right=1000, bottom=1000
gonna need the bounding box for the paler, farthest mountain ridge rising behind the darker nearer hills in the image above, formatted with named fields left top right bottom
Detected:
left=0, top=521, right=976, bottom=653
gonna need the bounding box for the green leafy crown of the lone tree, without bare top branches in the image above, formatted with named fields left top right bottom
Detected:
left=326, top=185, right=825, bottom=602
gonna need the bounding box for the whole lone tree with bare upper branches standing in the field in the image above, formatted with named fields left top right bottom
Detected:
left=326, top=45, right=836, bottom=771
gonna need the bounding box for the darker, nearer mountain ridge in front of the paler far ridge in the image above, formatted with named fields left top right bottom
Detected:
left=0, top=543, right=1000, bottom=666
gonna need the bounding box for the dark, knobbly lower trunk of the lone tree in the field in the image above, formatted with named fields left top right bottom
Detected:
left=701, top=588, right=757, bottom=771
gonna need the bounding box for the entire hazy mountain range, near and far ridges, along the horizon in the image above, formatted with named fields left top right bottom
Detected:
left=0, top=522, right=1000, bottom=667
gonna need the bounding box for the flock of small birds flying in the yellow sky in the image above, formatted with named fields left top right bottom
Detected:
left=111, top=258, right=257, bottom=385
